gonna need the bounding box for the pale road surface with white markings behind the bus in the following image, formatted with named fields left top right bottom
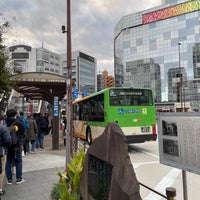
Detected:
left=129, top=142, right=200, bottom=200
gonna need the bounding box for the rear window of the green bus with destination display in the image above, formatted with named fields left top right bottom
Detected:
left=109, top=88, right=153, bottom=106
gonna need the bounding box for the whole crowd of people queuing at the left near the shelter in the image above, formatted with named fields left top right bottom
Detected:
left=0, top=109, right=50, bottom=196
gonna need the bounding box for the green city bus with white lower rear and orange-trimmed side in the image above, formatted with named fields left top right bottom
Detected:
left=73, top=87, right=157, bottom=144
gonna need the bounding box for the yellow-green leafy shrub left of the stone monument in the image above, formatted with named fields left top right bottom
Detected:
left=50, top=150, right=85, bottom=200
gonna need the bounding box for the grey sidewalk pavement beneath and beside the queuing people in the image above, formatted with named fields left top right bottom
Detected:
left=1, top=135, right=66, bottom=200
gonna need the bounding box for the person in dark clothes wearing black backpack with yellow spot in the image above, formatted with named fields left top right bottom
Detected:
left=5, top=109, right=25, bottom=185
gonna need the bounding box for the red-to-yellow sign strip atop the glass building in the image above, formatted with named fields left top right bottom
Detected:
left=142, top=0, right=200, bottom=24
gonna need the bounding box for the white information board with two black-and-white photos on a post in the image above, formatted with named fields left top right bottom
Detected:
left=158, top=112, right=200, bottom=174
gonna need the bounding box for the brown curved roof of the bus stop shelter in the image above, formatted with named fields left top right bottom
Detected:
left=10, top=72, right=66, bottom=105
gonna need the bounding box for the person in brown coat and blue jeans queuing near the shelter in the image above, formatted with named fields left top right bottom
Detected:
left=26, top=114, right=38, bottom=153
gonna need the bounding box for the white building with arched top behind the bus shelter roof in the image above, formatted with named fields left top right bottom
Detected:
left=9, top=45, right=61, bottom=74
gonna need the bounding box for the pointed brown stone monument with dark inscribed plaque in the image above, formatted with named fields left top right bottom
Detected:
left=80, top=122, right=141, bottom=200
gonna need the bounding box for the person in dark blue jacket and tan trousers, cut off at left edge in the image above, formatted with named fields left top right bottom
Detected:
left=0, top=114, right=11, bottom=195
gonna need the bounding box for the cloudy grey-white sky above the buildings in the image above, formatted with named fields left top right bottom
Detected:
left=0, top=0, right=161, bottom=75
